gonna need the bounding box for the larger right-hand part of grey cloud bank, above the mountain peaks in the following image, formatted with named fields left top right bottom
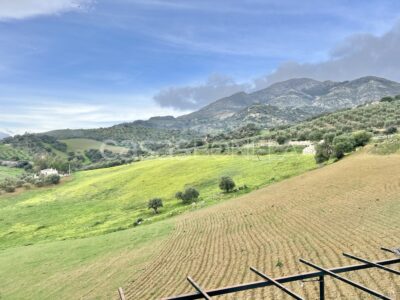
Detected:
left=256, top=23, right=400, bottom=88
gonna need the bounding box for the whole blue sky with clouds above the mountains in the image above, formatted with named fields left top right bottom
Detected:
left=0, top=0, right=400, bottom=134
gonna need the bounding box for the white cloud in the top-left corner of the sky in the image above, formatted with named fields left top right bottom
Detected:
left=0, top=0, right=92, bottom=21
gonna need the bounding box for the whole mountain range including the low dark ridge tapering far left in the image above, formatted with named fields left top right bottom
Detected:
left=43, top=76, right=400, bottom=141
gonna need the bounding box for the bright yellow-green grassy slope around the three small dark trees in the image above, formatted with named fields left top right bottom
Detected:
left=0, top=154, right=315, bottom=249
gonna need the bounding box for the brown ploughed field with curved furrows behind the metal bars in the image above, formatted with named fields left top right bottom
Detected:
left=123, top=153, right=400, bottom=299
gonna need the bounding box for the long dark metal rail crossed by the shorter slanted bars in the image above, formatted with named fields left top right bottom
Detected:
left=164, top=258, right=400, bottom=300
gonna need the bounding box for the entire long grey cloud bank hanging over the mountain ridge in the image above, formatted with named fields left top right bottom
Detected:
left=154, top=23, right=400, bottom=109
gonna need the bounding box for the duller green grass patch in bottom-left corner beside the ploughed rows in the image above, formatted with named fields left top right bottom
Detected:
left=0, top=219, right=173, bottom=300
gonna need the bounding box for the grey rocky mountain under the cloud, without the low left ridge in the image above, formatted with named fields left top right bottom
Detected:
left=130, top=76, right=400, bottom=132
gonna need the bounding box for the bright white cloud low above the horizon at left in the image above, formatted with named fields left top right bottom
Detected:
left=0, top=94, right=187, bottom=134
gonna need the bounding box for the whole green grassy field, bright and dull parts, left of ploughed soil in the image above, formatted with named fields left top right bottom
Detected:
left=0, top=154, right=316, bottom=299
